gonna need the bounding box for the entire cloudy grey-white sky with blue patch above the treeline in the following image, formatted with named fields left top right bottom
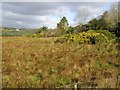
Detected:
left=0, top=2, right=115, bottom=28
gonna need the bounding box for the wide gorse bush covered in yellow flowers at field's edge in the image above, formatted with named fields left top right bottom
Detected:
left=55, top=30, right=108, bottom=44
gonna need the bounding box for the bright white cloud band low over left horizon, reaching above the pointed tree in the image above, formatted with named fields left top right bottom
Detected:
left=3, top=3, right=69, bottom=28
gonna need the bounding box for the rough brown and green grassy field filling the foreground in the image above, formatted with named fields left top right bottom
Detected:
left=2, top=36, right=118, bottom=88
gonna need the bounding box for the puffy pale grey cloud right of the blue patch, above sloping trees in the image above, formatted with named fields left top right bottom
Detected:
left=75, top=5, right=104, bottom=22
